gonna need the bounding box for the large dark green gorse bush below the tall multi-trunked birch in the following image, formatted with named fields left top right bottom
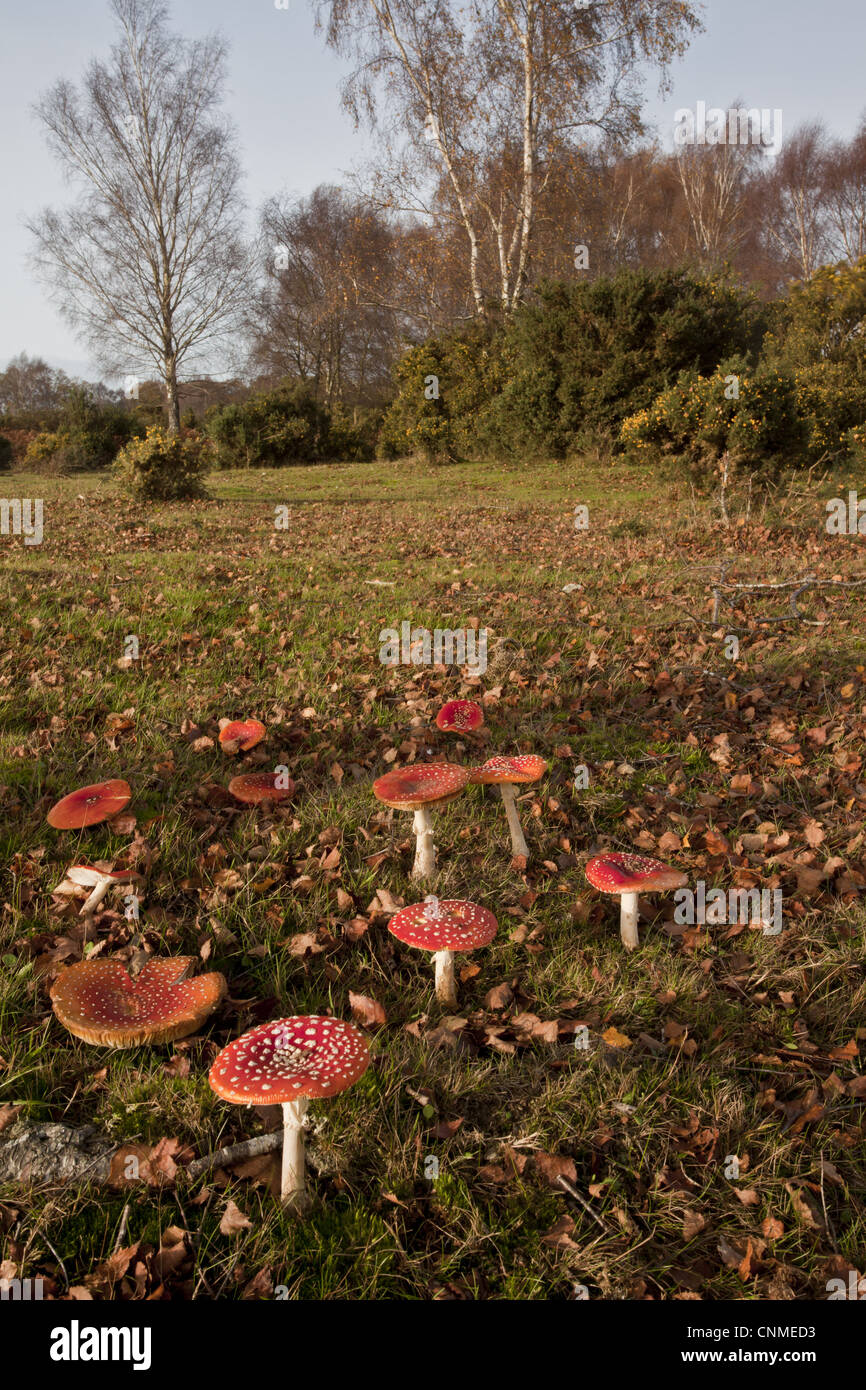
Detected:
left=379, top=271, right=767, bottom=459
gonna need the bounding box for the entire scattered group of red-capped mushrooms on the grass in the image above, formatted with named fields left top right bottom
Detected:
left=37, top=701, right=687, bottom=1211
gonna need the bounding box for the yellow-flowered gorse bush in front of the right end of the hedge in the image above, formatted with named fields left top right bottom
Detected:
left=620, top=360, right=808, bottom=484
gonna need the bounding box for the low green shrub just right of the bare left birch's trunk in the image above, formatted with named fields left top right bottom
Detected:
left=207, top=386, right=329, bottom=468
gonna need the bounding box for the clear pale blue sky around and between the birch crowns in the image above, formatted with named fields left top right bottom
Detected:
left=0, top=0, right=866, bottom=373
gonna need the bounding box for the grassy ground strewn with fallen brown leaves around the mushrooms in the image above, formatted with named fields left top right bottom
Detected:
left=0, top=463, right=866, bottom=1300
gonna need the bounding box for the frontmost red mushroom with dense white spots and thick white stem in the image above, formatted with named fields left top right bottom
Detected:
left=209, top=1015, right=370, bottom=1208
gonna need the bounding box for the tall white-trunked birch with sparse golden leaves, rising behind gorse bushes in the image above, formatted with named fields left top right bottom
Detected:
left=317, top=0, right=698, bottom=316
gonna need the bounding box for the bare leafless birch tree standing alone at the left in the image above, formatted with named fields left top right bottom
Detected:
left=31, top=0, right=252, bottom=432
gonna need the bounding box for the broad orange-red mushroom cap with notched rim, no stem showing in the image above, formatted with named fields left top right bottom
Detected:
left=50, top=956, right=225, bottom=1048
